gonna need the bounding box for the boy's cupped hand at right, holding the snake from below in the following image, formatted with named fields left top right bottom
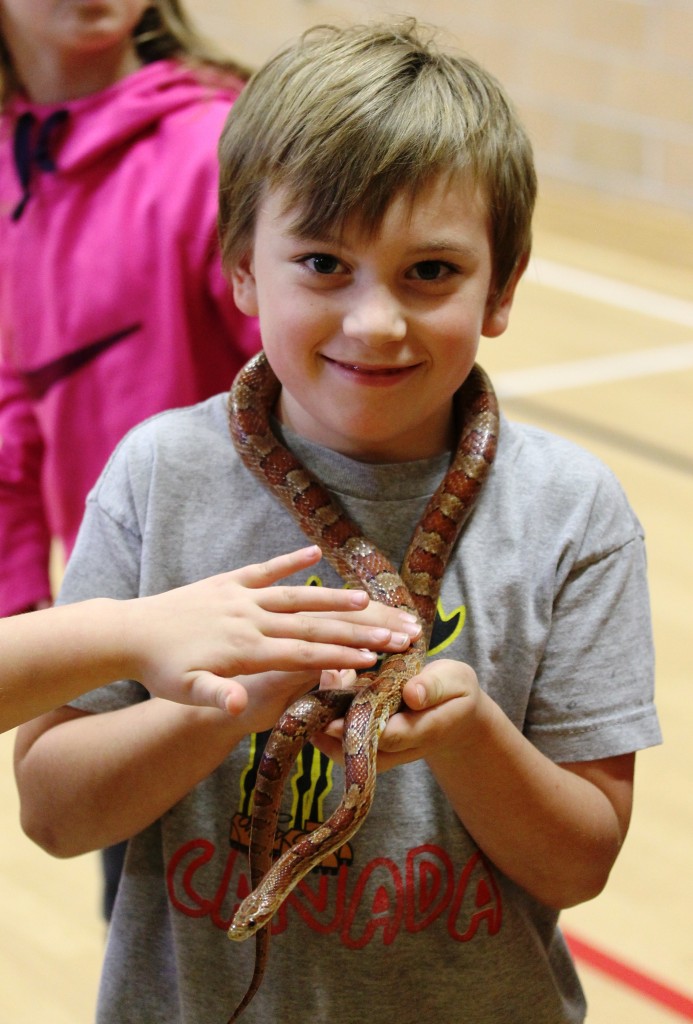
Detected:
left=311, top=659, right=481, bottom=772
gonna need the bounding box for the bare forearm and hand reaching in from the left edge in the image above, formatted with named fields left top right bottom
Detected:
left=0, top=547, right=419, bottom=731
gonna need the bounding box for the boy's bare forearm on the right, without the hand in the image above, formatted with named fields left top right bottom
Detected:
left=428, top=693, right=633, bottom=908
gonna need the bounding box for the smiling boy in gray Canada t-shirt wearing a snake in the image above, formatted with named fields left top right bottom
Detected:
left=17, top=24, right=659, bottom=1024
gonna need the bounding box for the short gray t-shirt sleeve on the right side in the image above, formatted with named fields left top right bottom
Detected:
left=524, top=470, right=661, bottom=762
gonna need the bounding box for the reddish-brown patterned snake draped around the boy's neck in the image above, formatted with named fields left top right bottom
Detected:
left=228, top=353, right=499, bottom=1024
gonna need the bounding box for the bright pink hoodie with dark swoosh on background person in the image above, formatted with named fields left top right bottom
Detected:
left=0, top=60, right=259, bottom=614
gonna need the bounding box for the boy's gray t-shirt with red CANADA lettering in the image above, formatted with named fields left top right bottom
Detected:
left=60, top=387, right=660, bottom=1024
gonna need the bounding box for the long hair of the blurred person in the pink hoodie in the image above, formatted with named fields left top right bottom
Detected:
left=0, top=0, right=250, bottom=108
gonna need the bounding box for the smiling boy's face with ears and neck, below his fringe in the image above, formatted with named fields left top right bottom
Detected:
left=231, top=177, right=519, bottom=462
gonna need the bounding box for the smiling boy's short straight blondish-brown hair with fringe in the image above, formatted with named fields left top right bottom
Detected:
left=219, top=19, right=536, bottom=297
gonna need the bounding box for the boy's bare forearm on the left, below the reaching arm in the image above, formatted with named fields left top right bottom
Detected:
left=15, top=698, right=243, bottom=857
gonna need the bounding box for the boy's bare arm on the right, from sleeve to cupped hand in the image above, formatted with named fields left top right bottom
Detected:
left=315, top=660, right=635, bottom=908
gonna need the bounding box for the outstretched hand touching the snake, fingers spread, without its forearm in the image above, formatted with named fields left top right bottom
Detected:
left=121, top=547, right=420, bottom=712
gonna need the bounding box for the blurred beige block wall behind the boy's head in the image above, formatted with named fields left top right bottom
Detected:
left=186, top=0, right=693, bottom=212
